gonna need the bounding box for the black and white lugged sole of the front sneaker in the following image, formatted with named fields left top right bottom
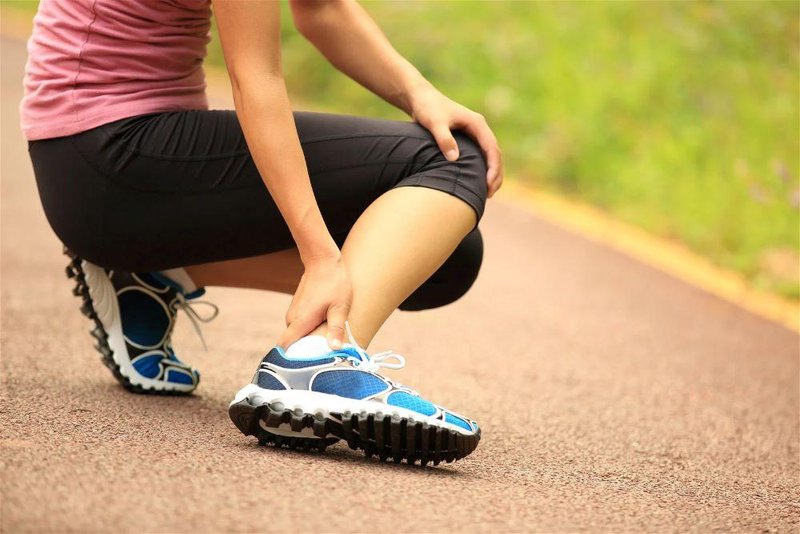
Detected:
left=228, top=388, right=481, bottom=466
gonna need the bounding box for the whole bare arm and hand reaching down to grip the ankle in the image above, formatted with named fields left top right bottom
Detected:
left=214, top=0, right=352, bottom=346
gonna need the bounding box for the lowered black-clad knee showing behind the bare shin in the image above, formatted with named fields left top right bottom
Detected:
left=400, top=228, right=483, bottom=311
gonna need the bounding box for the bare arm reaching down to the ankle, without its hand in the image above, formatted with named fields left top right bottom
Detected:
left=214, top=0, right=339, bottom=260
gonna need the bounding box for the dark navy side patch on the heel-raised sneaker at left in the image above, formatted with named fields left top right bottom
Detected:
left=118, top=288, right=170, bottom=347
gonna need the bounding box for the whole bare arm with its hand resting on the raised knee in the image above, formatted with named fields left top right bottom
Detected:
left=290, top=0, right=503, bottom=196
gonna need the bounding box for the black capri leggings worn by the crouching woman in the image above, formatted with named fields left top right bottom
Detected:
left=28, top=110, right=486, bottom=310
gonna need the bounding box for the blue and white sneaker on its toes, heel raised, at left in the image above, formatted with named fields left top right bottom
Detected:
left=65, top=250, right=218, bottom=395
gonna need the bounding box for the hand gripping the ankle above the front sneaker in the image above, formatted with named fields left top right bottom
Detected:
left=277, top=254, right=353, bottom=349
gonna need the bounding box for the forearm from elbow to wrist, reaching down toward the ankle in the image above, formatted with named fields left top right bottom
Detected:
left=233, top=76, right=338, bottom=263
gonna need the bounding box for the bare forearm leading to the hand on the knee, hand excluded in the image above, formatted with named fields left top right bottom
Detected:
left=292, top=0, right=433, bottom=115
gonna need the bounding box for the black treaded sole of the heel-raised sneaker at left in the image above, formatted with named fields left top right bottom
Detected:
left=64, top=248, right=196, bottom=396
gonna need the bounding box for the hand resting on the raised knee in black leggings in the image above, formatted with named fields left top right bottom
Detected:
left=411, top=88, right=503, bottom=197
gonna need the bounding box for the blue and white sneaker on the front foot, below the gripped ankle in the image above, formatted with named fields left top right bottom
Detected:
left=229, top=329, right=481, bottom=465
